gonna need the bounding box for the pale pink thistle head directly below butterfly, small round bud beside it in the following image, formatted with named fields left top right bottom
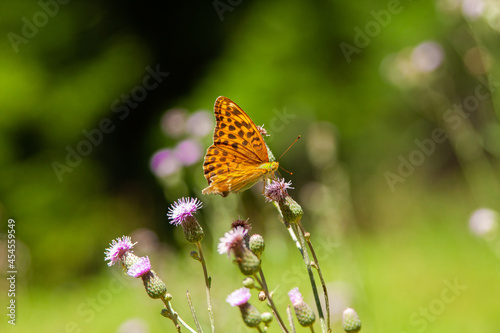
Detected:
left=217, top=226, right=260, bottom=275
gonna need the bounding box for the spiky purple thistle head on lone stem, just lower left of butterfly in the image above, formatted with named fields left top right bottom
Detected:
left=167, top=198, right=205, bottom=244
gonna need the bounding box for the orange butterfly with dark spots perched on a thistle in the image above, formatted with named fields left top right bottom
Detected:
left=202, top=96, right=279, bottom=197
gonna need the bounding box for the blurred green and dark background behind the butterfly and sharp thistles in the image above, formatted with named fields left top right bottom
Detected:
left=0, top=0, right=500, bottom=333
